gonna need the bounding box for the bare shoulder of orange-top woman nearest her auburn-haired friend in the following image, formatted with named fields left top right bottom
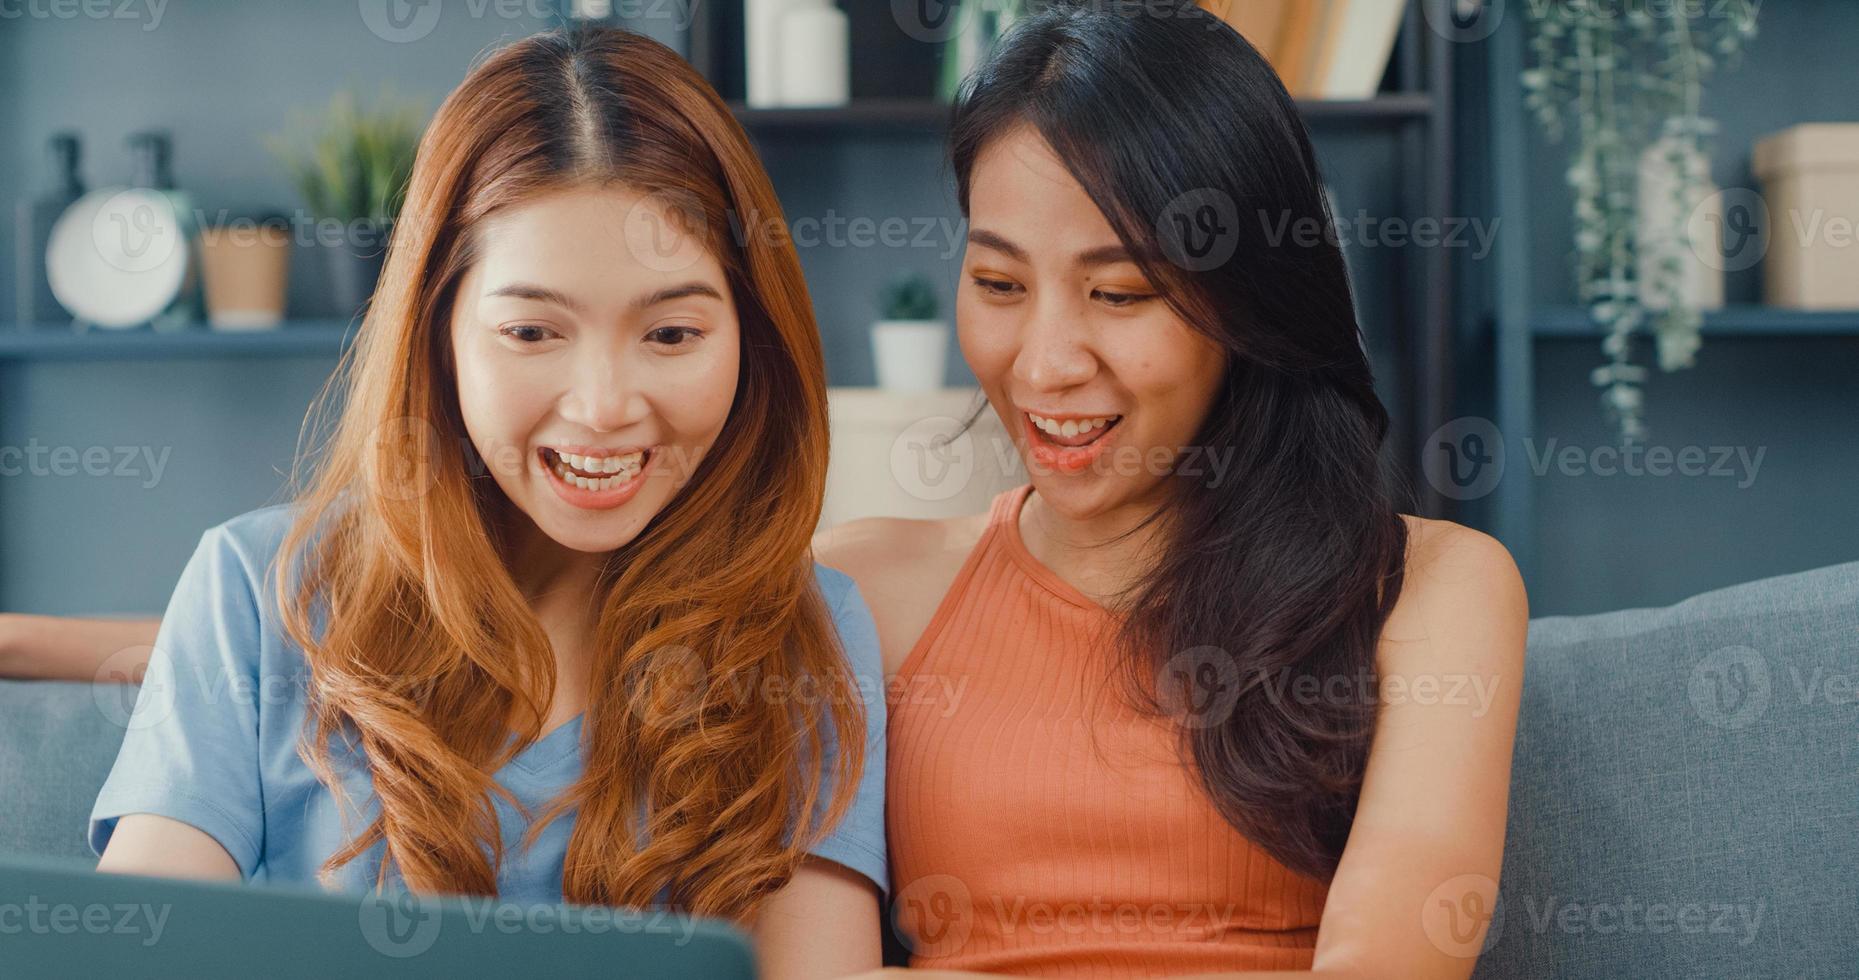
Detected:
left=814, top=513, right=987, bottom=675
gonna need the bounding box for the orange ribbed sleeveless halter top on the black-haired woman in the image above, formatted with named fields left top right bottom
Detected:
left=887, top=485, right=1327, bottom=976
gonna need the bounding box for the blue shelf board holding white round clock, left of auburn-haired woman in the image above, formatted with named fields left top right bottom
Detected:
left=0, top=320, right=361, bottom=361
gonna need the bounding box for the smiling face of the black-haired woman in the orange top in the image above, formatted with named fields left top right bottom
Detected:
left=956, top=126, right=1225, bottom=519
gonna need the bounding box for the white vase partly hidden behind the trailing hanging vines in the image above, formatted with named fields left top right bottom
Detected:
left=1634, top=136, right=1723, bottom=311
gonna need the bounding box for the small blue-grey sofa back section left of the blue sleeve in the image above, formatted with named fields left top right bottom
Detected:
left=0, top=681, right=138, bottom=857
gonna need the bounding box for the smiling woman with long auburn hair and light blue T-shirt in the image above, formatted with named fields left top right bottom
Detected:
left=68, top=28, right=887, bottom=976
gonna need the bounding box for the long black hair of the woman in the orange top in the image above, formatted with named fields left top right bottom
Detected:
left=950, top=4, right=1407, bottom=880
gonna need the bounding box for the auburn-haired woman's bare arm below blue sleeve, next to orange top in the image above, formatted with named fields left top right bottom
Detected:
left=753, top=857, right=885, bottom=980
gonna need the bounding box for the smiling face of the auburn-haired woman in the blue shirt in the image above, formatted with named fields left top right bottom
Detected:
left=452, top=184, right=740, bottom=552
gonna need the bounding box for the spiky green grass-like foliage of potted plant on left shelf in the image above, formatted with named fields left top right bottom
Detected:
left=262, top=91, right=426, bottom=227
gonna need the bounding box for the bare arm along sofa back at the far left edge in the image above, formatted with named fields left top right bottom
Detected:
left=0, top=612, right=162, bottom=682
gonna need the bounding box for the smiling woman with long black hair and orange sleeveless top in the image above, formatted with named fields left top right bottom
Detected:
left=816, top=6, right=1528, bottom=976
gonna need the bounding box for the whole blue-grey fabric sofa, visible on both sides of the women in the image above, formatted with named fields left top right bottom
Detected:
left=0, top=562, right=1859, bottom=980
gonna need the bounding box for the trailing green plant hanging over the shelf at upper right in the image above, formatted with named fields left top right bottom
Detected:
left=1523, top=0, right=1757, bottom=443
